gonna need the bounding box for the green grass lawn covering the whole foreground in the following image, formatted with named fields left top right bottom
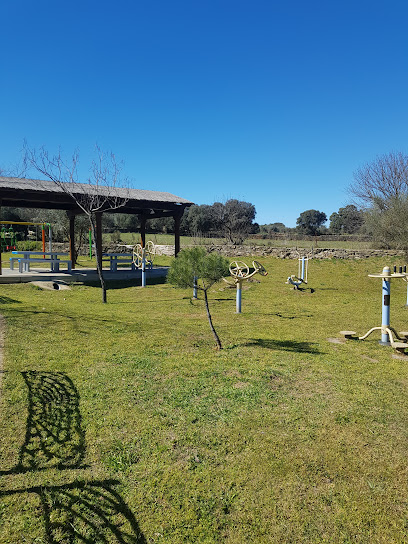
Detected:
left=0, top=258, right=408, bottom=544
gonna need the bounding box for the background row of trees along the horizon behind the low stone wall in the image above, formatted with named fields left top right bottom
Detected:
left=1, top=152, right=408, bottom=249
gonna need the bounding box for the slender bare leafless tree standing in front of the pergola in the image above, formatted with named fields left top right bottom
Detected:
left=25, top=145, right=129, bottom=303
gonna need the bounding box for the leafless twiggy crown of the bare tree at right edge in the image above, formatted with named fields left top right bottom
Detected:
left=349, top=151, right=408, bottom=206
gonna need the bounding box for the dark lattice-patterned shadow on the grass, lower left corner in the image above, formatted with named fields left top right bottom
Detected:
left=0, top=371, right=146, bottom=544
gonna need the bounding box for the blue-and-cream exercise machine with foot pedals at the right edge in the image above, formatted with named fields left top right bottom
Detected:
left=340, top=266, right=408, bottom=353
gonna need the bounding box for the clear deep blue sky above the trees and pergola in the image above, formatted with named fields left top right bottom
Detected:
left=0, top=0, right=408, bottom=226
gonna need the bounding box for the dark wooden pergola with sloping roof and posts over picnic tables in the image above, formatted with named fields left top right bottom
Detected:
left=0, top=176, right=193, bottom=273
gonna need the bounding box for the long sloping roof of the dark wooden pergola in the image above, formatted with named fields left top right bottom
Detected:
left=0, top=176, right=193, bottom=218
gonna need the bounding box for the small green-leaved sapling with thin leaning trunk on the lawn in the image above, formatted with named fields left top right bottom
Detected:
left=167, top=247, right=229, bottom=349
